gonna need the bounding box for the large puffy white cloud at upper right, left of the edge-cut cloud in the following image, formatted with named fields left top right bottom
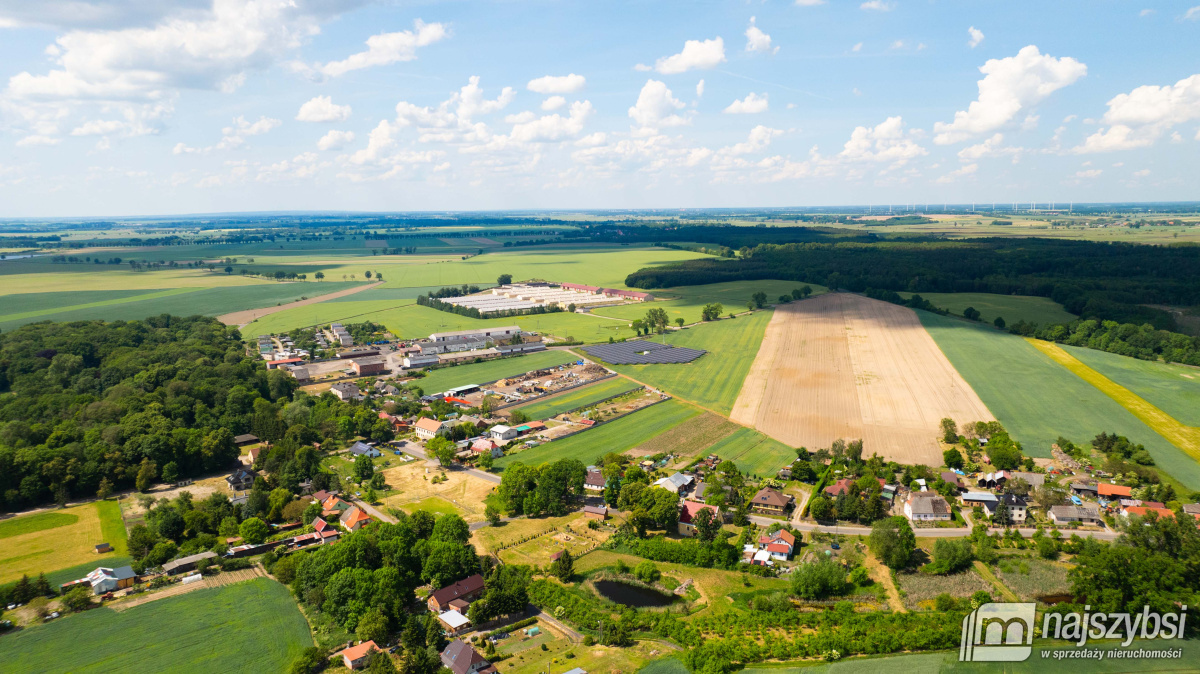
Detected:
left=934, top=44, right=1087, bottom=145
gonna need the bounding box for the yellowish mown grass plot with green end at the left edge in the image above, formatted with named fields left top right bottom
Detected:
left=0, top=500, right=126, bottom=583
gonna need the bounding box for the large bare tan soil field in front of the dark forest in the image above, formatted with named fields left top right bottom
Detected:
left=731, top=293, right=994, bottom=465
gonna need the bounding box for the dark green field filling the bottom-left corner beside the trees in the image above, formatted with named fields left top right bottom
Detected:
left=0, top=570, right=313, bottom=674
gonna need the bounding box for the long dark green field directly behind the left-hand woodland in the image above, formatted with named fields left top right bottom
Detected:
left=0, top=283, right=359, bottom=330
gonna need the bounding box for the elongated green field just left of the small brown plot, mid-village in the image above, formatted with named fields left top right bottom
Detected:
left=496, top=401, right=700, bottom=470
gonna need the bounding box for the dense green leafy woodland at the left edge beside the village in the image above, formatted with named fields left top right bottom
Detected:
left=0, top=315, right=296, bottom=510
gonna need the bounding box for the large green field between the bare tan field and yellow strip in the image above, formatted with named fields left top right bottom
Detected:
left=917, top=311, right=1200, bottom=489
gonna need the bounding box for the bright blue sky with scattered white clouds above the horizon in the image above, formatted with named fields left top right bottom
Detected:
left=0, top=0, right=1200, bottom=217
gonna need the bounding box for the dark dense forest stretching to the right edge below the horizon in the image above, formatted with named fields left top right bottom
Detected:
left=625, top=236, right=1200, bottom=330
